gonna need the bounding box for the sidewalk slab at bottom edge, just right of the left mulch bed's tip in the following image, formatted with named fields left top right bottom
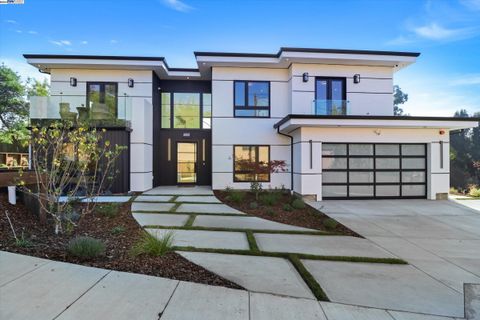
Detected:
left=250, top=292, right=327, bottom=320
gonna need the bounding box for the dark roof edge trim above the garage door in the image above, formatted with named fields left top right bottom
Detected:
left=273, top=114, right=480, bottom=129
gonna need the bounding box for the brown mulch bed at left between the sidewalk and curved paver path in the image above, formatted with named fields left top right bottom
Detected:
left=0, top=193, right=243, bottom=289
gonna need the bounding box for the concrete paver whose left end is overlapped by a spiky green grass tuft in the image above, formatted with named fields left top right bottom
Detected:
left=145, top=228, right=249, bottom=250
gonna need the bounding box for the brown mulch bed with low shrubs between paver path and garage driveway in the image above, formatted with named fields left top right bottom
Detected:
left=214, top=190, right=361, bottom=237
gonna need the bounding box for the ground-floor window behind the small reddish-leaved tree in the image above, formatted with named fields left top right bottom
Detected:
left=233, top=146, right=270, bottom=182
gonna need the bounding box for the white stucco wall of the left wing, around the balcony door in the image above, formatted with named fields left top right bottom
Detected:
left=50, top=69, right=153, bottom=191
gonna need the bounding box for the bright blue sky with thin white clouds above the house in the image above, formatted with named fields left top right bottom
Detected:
left=0, top=0, right=480, bottom=116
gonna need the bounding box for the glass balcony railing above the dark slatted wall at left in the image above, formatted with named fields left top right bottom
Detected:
left=29, top=95, right=132, bottom=127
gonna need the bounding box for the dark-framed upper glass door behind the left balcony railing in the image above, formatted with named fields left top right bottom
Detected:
left=87, top=82, right=117, bottom=120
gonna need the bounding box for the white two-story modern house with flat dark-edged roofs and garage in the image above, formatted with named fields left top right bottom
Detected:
left=24, top=48, right=478, bottom=200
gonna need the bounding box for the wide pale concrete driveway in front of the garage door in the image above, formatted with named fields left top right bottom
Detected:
left=307, top=200, right=480, bottom=316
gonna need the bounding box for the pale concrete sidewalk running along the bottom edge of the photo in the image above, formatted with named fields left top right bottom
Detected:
left=0, top=251, right=464, bottom=320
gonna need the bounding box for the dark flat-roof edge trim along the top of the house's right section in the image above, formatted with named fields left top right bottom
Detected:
left=194, top=47, right=420, bottom=58
